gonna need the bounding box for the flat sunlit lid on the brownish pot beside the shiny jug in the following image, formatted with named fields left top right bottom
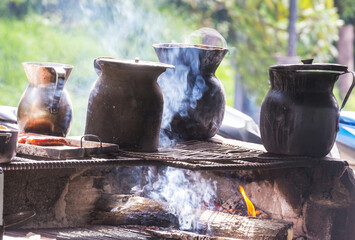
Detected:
left=95, top=57, right=175, bottom=70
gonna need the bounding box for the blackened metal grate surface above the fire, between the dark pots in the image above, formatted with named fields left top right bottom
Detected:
left=120, top=141, right=344, bottom=171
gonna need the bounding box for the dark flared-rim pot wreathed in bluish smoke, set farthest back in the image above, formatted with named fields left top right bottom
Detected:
left=153, top=44, right=228, bottom=140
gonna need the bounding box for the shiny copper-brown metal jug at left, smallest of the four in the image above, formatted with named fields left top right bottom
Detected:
left=17, top=62, right=73, bottom=137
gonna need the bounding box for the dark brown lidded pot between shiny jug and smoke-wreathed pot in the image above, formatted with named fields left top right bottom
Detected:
left=85, top=58, right=173, bottom=152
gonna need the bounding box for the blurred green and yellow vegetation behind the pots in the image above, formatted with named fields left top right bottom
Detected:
left=0, top=0, right=355, bottom=135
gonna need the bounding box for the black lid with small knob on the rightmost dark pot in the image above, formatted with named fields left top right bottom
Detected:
left=269, top=59, right=348, bottom=72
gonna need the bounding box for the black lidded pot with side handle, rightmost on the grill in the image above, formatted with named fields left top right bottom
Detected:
left=260, top=59, right=354, bottom=157
